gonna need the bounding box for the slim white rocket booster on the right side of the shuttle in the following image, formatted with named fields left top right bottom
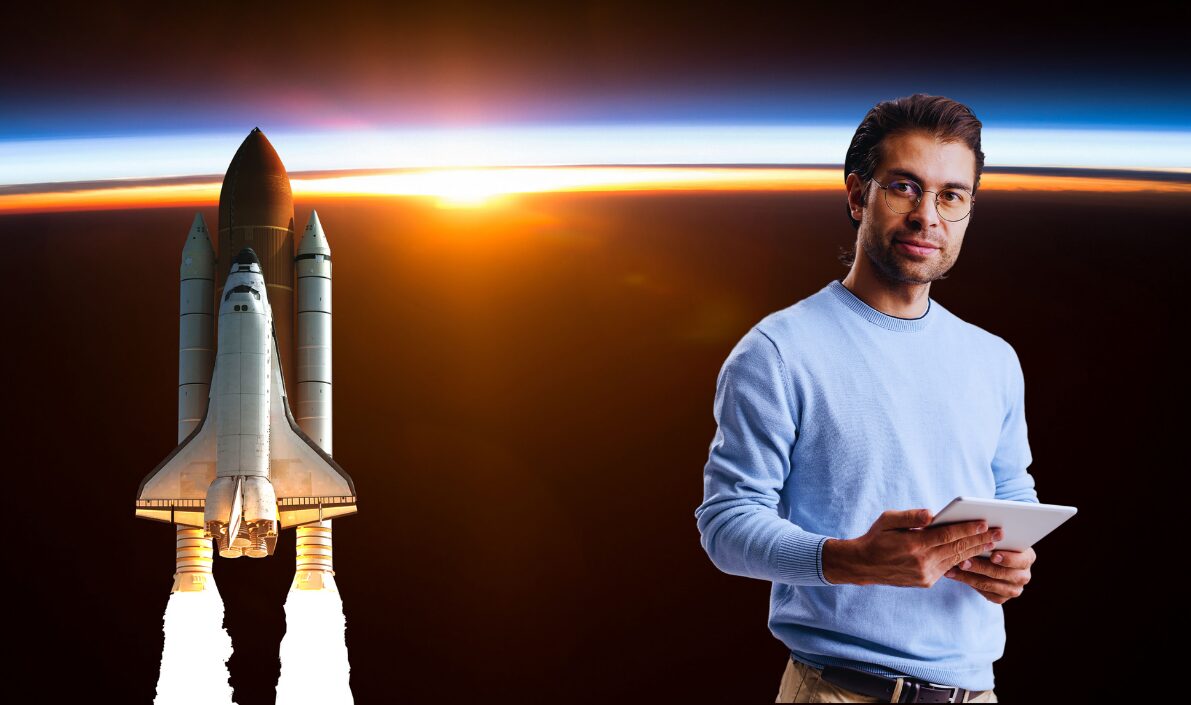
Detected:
left=291, top=211, right=337, bottom=591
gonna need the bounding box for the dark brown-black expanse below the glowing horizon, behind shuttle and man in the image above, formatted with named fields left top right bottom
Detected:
left=0, top=184, right=1191, bottom=705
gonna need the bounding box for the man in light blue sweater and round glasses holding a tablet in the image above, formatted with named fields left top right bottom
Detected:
left=696, top=94, right=1037, bottom=703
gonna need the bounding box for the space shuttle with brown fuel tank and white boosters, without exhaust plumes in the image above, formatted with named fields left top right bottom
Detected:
left=136, top=129, right=356, bottom=592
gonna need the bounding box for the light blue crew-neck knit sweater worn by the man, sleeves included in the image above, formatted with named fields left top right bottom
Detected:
left=694, top=281, right=1037, bottom=690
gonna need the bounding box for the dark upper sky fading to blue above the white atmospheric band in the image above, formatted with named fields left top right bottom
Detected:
left=0, top=2, right=1191, bottom=138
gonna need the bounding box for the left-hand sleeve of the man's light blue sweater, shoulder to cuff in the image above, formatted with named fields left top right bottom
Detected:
left=694, top=327, right=834, bottom=585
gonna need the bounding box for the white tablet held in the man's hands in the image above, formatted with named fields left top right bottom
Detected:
left=930, top=497, right=1075, bottom=559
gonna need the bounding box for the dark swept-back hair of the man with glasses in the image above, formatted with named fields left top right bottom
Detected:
left=840, top=93, right=984, bottom=268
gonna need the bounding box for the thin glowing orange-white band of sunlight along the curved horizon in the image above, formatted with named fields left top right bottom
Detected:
left=0, top=167, right=1191, bottom=213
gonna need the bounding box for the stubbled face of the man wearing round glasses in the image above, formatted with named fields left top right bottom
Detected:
left=848, top=132, right=975, bottom=283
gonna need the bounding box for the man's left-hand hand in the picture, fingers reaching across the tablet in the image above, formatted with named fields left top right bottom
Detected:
left=823, top=510, right=1003, bottom=587
